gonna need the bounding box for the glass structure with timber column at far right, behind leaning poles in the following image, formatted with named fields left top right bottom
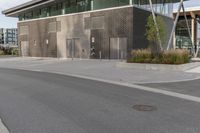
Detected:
left=174, top=6, right=200, bottom=50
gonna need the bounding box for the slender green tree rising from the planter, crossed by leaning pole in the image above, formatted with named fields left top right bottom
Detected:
left=145, top=15, right=167, bottom=53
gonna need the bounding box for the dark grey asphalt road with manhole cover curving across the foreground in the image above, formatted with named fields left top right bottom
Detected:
left=0, top=68, right=200, bottom=133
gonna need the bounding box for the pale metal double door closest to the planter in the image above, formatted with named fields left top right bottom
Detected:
left=110, top=37, right=127, bottom=59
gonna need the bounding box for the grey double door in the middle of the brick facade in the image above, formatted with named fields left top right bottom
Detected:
left=66, top=38, right=82, bottom=58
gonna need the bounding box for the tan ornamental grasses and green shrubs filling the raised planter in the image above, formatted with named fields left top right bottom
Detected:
left=128, top=49, right=189, bottom=64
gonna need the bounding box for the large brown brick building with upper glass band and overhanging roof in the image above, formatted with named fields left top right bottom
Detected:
left=3, top=0, right=180, bottom=59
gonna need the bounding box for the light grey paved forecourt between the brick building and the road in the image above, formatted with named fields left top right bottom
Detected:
left=0, top=57, right=200, bottom=84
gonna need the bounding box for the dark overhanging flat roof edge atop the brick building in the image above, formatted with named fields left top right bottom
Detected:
left=2, top=0, right=186, bottom=17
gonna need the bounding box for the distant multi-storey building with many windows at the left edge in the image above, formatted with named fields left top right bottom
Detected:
left=0, top=28, right=18, bottom=45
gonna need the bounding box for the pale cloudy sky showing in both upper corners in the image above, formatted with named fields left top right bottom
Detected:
left=0, top=0, right=200, bottom=28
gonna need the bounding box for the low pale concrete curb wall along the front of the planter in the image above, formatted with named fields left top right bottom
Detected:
left=116, top=62, right=200, bottom=72
